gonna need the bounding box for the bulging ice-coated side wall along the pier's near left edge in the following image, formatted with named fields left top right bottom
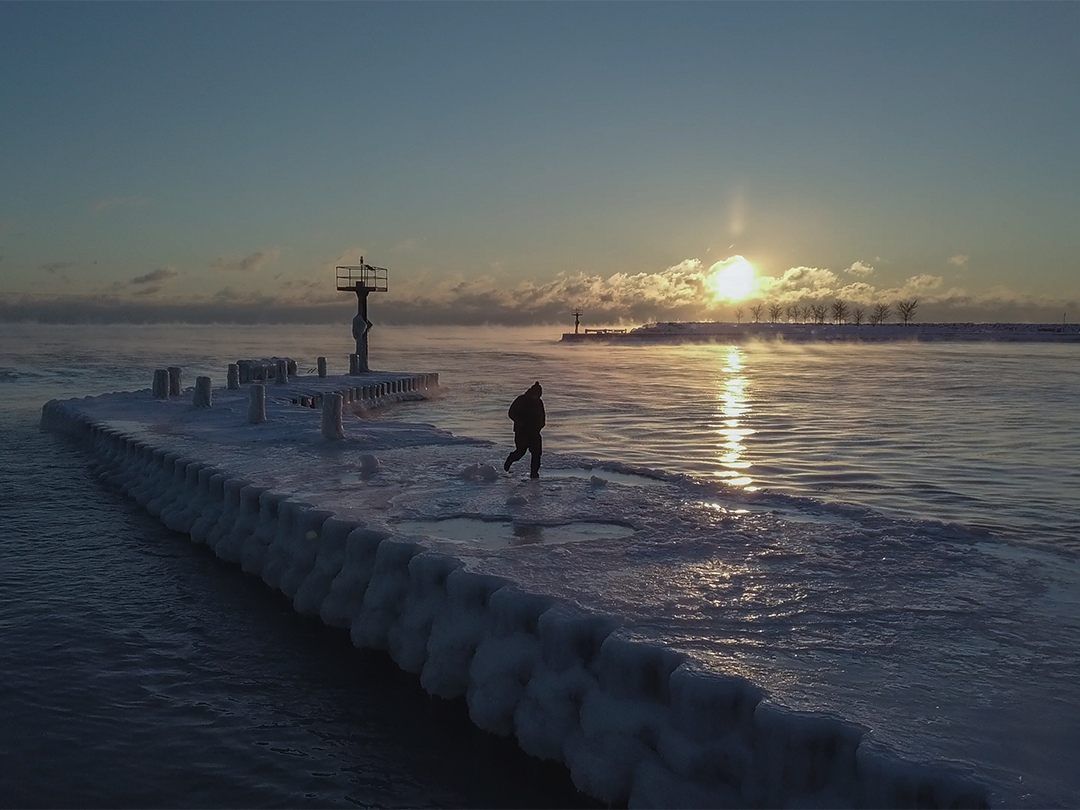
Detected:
left=42, top=400, right=988, bottom=807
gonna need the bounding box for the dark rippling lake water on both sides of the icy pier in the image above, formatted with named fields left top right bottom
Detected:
left=0, top=325, right=1080, bottom=806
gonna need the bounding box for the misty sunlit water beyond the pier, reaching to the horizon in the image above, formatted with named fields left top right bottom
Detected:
left=0, top=324, right=1080, bottom=551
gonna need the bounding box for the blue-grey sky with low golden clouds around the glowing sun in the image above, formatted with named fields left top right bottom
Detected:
left=0, top=2, right=1080, bottom=323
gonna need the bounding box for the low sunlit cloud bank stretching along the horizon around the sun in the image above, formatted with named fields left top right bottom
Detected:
left=0, top=258, right=1080, bottom=325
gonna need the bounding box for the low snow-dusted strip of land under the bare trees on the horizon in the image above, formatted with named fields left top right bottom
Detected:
left=562, top=321, right=1080, bottom=343
